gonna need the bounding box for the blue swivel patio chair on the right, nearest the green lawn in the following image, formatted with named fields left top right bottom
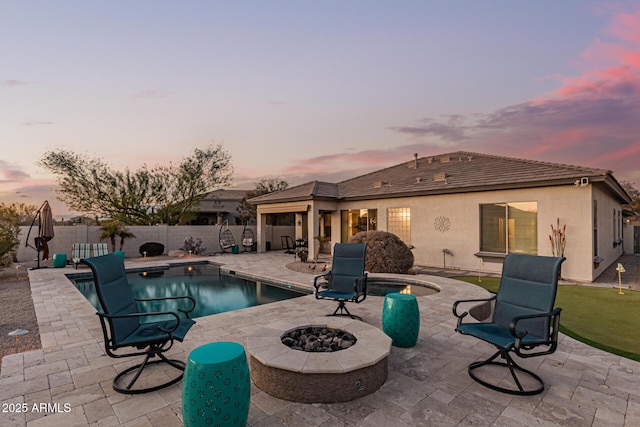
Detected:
left=453, top=254, right=565, bottom=395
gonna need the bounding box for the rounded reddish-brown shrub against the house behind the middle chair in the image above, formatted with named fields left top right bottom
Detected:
left=349, top=231, right=414, bottom=274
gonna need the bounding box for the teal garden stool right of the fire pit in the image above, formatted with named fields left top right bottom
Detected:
left=382, top=293, right=420, bottom=347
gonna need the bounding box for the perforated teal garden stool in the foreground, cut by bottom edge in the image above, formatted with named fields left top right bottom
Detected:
left=182, top=342, right=251, bottom=427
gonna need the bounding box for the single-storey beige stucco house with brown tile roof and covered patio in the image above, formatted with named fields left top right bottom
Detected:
left=250, top=151, right=631, bottom=282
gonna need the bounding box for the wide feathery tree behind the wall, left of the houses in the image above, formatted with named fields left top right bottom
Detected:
left=38, top=145, right=232, bottom=225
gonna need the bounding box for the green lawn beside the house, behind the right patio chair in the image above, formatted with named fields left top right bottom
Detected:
left=455, top=276, right=640, bottom=361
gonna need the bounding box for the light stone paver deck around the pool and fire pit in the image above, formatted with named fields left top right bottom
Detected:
left=0, top=253, right=640, bottom=427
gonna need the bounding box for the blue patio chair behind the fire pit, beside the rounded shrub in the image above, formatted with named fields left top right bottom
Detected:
left=313, top=243, right=367, bottom=320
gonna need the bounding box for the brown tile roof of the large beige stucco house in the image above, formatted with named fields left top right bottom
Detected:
left=251, top=151, right=621, bottom=203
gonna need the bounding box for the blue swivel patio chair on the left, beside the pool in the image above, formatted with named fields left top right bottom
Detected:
left=82, top=254, right=195, bottom=394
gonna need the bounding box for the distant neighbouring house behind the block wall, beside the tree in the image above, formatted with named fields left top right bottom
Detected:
left=190, top=189, right=248, bottom=225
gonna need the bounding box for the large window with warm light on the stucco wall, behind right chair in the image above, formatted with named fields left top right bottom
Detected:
left=480, top=202, right=538, bottom=255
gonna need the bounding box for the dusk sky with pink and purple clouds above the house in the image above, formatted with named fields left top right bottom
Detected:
left=0, top=0, right=640, bottom=221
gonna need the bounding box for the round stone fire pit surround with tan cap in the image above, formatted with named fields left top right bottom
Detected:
left=247, top=317, right=391, bottom=403
